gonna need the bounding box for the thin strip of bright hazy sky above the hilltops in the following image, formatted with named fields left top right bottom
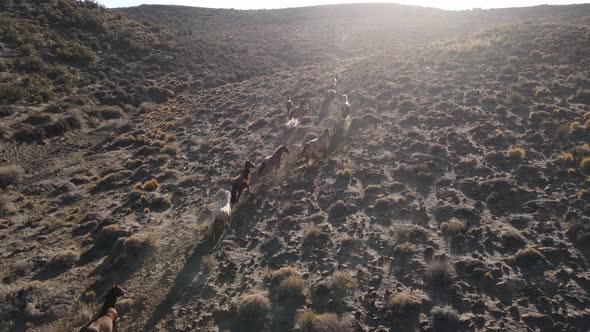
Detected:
left=98, top=0, right=587, bottom=10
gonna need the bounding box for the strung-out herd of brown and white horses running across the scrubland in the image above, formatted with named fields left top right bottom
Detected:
left=80, top=78, right=351, bottom=332
